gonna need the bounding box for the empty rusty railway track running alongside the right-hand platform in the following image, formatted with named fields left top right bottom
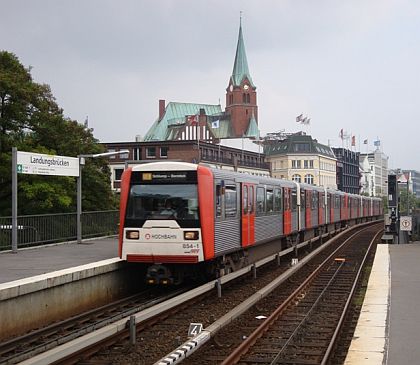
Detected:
left=185, top=226, right=380, bottom=365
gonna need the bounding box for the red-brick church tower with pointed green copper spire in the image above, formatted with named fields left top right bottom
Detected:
left=226, top=22, right=258, bottom=137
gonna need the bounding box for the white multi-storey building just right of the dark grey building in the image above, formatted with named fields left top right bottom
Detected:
left=359, top=148, right=389, bottom=197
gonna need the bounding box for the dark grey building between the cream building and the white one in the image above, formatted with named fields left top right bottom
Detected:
left=332, top=147, right=361, bottom=194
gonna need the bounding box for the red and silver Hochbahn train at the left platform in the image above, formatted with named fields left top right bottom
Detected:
left=119, top=161, right=383, bottom=284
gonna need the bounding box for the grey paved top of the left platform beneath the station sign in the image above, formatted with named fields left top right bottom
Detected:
left=0, top=237, right=118, bottom=283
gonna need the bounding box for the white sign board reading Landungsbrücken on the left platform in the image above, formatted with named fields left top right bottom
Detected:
left=16, top=151, right=79, bottom=177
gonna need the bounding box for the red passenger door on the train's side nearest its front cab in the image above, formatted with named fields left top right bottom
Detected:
left=241, top=183, right=255, bottom=247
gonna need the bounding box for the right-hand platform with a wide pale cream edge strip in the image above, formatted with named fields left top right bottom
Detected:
left=345, top=242, right=420, bottom=365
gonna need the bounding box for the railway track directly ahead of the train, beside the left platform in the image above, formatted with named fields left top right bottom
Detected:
left=0, top=288, right=187, bottom=364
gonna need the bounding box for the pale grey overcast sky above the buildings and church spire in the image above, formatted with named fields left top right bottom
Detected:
left=0, top=0, right=420, bottom=171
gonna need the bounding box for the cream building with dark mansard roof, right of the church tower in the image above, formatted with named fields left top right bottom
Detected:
left=264, top=133, right=337, bottom=189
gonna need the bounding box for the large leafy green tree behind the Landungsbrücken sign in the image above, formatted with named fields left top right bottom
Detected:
left=0, top=51, right=117, bottom=215
